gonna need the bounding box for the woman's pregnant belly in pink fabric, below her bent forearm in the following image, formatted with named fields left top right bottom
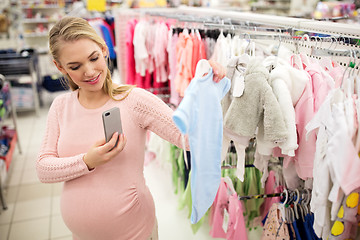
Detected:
left=61, top=180, right=155, bottom=240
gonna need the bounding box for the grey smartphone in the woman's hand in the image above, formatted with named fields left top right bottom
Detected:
left=102, top=107, right=122, bottom=147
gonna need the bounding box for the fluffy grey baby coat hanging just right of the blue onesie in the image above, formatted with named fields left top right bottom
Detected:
left=224, top=59, right=287, bottom=147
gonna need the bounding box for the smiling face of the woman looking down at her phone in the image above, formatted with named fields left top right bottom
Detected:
left=55, top=39, right=108, bottom=92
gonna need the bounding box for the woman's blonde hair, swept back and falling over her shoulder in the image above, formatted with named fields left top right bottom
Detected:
left=49, top=17, right=134, bottom=100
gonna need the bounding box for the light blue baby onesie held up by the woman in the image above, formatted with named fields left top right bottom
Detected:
left=173, top=69, right=231, bottom=224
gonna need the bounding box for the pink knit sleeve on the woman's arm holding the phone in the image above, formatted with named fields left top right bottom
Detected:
left=36, top=96, right=90, bottom=183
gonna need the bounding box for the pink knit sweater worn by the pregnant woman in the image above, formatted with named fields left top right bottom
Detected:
left=36, top=88, right=182, bottom=240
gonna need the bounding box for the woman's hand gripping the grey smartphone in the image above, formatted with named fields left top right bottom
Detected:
left=84, top=132, right=126, bottom=170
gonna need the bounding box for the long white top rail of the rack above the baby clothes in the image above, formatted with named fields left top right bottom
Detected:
left=131, top=6, right=360, bottom=39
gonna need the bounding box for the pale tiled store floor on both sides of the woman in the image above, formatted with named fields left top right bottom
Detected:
left=0, top=91, right=236, bottom=240
